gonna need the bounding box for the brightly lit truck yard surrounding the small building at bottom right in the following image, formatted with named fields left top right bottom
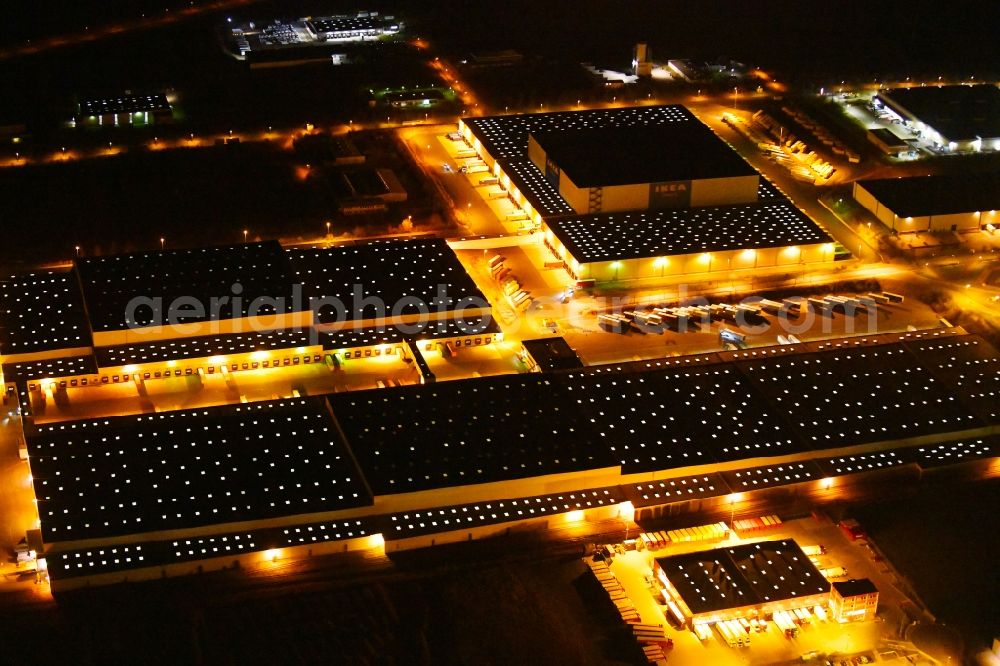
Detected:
left=588, top=518, right=929, bottom=666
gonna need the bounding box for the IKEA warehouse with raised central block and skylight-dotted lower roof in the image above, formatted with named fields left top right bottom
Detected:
left=459, top=105, right=836, bottom=281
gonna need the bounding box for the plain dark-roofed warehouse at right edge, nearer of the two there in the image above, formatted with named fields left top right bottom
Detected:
left=854, top=172, right=1000, bottom=233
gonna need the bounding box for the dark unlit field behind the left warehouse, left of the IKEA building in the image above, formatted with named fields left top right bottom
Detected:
left=0, top=132, right=440, bottom=268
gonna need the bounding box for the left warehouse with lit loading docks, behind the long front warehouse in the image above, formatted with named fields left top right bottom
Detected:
left=0, top=239, right=502, bottom=417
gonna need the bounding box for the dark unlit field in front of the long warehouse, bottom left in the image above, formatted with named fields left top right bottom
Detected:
left=0, top=557, right=638, bottom=666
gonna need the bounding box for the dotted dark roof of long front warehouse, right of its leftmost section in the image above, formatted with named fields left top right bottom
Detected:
left=330, top=335, right=997, bottom=494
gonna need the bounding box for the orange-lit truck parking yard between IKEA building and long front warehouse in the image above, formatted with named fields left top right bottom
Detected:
left=456, top=242, right=941, bottom=365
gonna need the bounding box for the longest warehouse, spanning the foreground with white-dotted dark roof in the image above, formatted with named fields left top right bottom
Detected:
left=5, top=302, right=1000, bottom=588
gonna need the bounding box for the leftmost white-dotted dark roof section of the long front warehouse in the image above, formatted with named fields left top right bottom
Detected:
left=28, top=398, right=371, bottom=543
